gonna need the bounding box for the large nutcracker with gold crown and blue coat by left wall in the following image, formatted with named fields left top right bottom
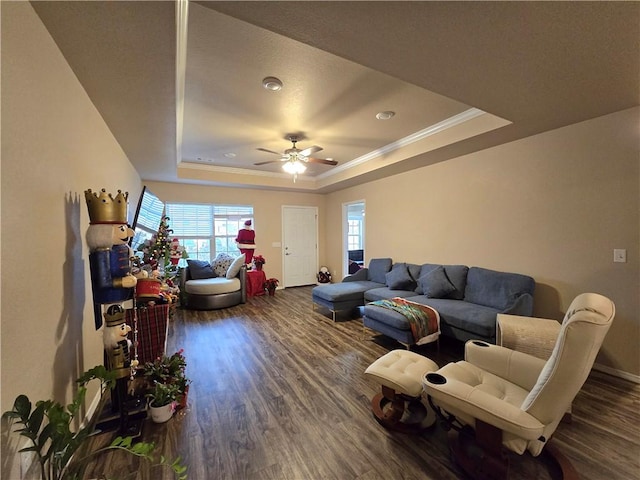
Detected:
left=84, top=188, right=136, bottom=330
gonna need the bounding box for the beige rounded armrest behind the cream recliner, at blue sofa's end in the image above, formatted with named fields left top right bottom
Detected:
left=496, top=313, right=562, bottom=360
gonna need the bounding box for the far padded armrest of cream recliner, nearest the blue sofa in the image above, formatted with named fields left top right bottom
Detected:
left=464, top=340, right=547, bottom=390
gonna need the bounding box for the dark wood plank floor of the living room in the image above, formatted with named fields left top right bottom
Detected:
left=87, top=287, right=640, bottom=480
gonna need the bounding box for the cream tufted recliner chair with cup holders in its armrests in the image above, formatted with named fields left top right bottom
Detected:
left=423, top=293, right=615, bottom=479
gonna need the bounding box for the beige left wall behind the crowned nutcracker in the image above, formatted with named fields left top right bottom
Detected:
left=0, top=2, right=141, bottom=478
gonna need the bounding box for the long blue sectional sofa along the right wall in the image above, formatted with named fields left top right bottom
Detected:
left=312, top=258, right=535, bottom=345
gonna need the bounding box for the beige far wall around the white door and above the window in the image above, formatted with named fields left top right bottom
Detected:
left=144, top=182, right=325, bottom=281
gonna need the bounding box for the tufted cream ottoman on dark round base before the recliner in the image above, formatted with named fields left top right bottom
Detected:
left=364, top=350, right=438, bottom=433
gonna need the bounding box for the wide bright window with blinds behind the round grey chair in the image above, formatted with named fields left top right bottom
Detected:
left=166, top=203, right=253, bottom=262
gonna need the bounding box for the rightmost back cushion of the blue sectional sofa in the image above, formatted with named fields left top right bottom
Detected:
left=464, top=267, right=535, bottom=311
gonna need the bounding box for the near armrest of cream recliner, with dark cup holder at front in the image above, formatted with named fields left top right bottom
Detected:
left=423, top=372, right=545, bottom=440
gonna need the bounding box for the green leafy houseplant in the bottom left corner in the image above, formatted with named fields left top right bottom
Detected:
left=2, top=365, right=187, bottom=480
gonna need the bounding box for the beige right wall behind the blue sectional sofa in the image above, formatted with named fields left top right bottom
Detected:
left=326, top=108, right=640, bottom=376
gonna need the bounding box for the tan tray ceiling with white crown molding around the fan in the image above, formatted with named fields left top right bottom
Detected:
left=32, top=1, right=640, bottom=193
